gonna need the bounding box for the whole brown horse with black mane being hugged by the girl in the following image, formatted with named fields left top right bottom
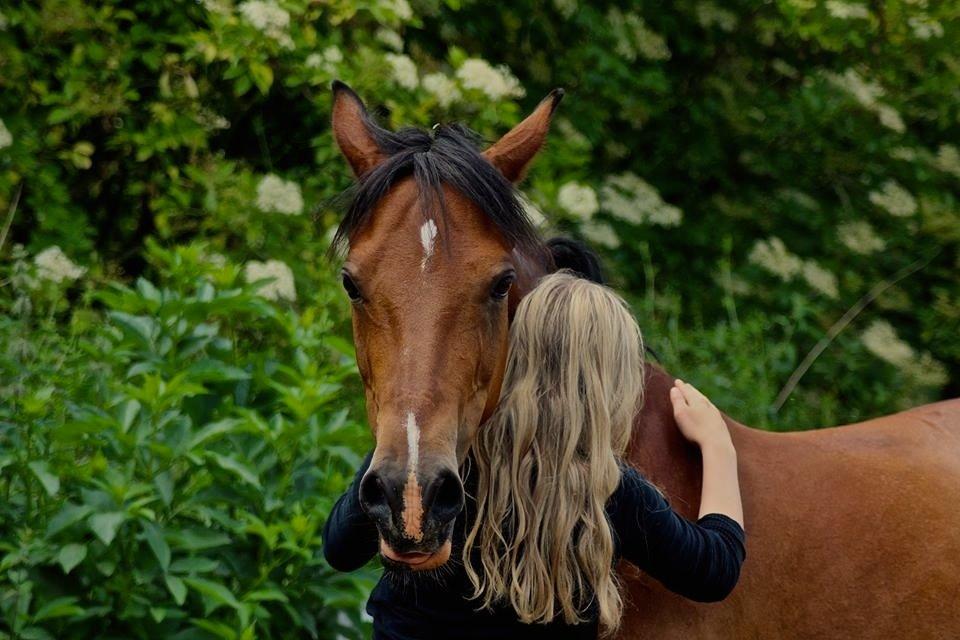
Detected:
left=333, top=83, right=960, bottom=638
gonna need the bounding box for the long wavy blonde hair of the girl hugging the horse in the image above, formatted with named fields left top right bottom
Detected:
left=463, top=272, right=643, bottom=633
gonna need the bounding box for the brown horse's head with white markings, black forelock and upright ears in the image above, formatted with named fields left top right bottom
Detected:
left=333, top=82, right=563, bottom=570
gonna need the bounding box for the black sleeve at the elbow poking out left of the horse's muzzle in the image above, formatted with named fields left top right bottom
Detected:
left=323, top=452, right=379, bottom=571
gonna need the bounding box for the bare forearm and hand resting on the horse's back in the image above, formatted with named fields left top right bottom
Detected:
left=670, top=380, right=743, bottom=527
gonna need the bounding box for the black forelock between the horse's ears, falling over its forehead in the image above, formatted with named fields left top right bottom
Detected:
left=331, top=113, right=543, bottom=251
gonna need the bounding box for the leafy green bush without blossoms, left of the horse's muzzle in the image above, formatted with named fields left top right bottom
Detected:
left=0, top=247, right=374, bottom=639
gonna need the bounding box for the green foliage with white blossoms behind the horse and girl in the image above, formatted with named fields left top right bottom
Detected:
left=0, top=0, right=960, bottom=639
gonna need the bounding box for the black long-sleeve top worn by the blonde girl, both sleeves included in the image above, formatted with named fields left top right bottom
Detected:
left=323, top=455, right=746, bottom=640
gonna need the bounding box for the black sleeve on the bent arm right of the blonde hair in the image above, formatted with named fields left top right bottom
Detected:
left=608, top=466, right=746, bottom=602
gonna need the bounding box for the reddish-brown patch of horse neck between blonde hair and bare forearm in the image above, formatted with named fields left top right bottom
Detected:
left=627, top=364, right=702, bottom=517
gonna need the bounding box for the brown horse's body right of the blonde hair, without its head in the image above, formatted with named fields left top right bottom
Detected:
left=617, top=367, right=960, bottom=639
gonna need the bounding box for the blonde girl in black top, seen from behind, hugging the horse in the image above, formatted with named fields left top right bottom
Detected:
left=324, top=273, right=746, bottom=640
